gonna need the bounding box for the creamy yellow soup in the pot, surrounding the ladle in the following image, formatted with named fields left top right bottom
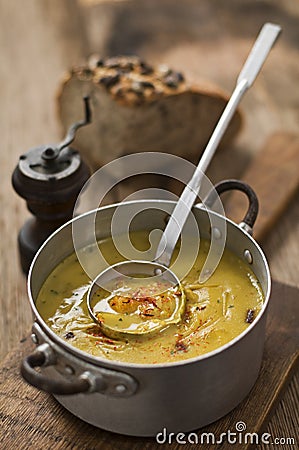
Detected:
left=36, top=232, right=264, bottom=364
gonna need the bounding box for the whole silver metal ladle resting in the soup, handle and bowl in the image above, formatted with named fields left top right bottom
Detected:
left=87, top=23, right=281, bottom=338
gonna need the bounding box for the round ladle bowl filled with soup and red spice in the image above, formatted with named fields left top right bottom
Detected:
left=87, top=260, right=185, bottom=339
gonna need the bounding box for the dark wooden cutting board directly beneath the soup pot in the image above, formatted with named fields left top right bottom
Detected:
left=0, top=282, right=299, bottom=450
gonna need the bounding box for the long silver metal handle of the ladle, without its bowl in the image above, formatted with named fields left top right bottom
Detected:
left=155, top=23, right=281, bottom=267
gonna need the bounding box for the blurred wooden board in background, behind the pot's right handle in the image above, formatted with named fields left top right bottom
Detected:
left=225, top=132, right=299, bottom=242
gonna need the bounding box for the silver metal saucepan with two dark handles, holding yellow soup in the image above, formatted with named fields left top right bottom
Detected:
left=21, top=181, right=271, bottom=436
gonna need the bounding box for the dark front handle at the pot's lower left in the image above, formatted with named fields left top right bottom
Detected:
left=21, top=344, right=91, bottom=395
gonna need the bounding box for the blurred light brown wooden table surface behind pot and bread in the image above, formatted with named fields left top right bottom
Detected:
left=0, top=0, right=299, bottom=449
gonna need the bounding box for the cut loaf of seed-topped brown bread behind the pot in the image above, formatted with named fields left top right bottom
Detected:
left=58, top=56, right=241, bottom=169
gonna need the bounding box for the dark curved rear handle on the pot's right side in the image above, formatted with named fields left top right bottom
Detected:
left=203, top=180, right=259, bottom=234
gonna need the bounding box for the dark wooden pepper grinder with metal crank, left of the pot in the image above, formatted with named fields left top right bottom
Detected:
left=12, top=97, right=91, bottom=274
